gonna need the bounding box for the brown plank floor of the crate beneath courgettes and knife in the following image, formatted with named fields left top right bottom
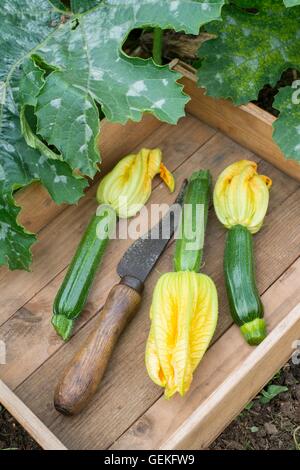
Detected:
left=0, top=111, right=300, bottom=449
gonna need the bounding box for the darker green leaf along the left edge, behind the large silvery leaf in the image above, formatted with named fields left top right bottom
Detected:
left=0, top=0, right=86, bottom=269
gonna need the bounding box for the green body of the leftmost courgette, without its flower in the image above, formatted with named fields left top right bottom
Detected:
left=52, top=206, right=116, bottom=341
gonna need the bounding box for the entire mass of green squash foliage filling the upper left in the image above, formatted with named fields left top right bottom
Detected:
left=0, top=0, right=224, bottom=269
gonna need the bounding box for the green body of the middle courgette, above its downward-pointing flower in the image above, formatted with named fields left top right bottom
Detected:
left=174, top=170, right=212, bottom=272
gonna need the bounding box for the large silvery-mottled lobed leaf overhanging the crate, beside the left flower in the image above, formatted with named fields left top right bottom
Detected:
left=32, top=0, right=224, bottom=176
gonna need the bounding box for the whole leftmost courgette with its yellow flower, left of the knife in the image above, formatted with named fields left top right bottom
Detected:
left=52, top=149, right=175, bottom=341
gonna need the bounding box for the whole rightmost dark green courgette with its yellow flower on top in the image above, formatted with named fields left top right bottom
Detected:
left=214, top=160, right=272, bottom=345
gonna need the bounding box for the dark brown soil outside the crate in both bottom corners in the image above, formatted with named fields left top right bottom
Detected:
left=0, top=362, right=300, bottom=450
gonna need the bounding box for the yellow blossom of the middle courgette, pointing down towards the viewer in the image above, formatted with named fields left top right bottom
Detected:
left=146, top=271, right=218, bottom=398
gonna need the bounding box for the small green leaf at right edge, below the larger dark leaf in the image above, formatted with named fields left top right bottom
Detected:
left=273, top=86, right=300, bottom=162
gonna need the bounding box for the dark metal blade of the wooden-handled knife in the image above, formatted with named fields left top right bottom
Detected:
left=117, top=180, right=187, bottom=282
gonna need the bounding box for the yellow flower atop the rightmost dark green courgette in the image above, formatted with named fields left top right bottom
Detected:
left=214, top=160, right=272, bottom=233
